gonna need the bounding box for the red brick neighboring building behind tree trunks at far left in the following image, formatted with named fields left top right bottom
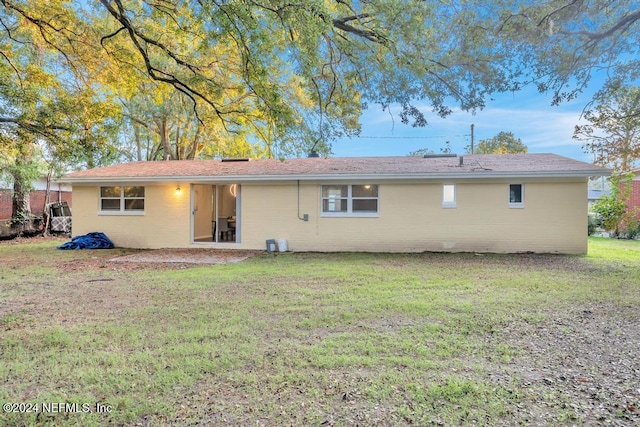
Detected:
left=0, top=178, right=71, bottom=220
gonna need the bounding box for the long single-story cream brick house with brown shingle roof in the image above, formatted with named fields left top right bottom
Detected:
left=63, top=154, right=610, bottom=253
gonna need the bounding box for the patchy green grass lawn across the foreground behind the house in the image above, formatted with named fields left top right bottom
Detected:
left=0, top=238, right=640, bottom=426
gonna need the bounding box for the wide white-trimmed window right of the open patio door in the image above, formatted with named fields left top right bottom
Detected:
left=322, top=184, right=379, bottom=216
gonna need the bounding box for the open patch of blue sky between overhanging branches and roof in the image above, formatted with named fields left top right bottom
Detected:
left=332, top=83, right=599, bottom=162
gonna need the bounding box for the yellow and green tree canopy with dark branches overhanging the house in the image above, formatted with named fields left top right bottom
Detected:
left=0, top=0, right=640, bottom=165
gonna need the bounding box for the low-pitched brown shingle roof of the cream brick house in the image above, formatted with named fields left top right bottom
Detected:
left=62, top=154, right=610, bottom=183
